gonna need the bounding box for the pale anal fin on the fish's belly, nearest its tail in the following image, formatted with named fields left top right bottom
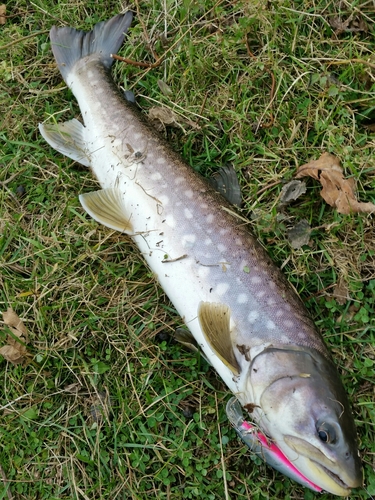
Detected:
left=39, top=118, right=90, bottom=167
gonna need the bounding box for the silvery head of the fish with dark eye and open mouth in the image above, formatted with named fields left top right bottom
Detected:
left=250, top=346, right=362, bottom=496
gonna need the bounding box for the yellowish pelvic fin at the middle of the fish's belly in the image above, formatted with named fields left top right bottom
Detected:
left=79, top=188, right=134, bottom=234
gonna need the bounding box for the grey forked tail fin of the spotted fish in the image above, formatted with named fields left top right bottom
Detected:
left=50, top=12, right=133, bottom=83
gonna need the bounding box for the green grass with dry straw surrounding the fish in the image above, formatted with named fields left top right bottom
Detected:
left=0, top=0, right=375, bottom=500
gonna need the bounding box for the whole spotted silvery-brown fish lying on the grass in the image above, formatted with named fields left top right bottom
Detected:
left=39, top=12, right=362, bottom=496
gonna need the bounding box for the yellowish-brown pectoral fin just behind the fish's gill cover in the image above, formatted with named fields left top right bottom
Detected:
left=198, top=302, right=241, bottom=375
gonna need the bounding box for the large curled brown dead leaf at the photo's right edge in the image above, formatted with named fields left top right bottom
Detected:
left=296, top=153, right=375, bottom=214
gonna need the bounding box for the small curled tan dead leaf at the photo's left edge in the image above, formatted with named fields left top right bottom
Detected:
left=0, top=307, right=28, bottom=365
